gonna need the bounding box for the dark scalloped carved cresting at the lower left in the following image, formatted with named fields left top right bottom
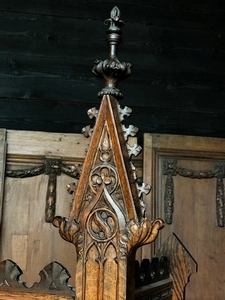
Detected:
left=0, top=260, right=75, bottom=296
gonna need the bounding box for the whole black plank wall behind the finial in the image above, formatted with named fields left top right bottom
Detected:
left=0, top=0, right=225, bottom=143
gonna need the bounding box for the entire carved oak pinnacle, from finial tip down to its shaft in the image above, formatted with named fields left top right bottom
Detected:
left=53, top=8, right=163, bottom=300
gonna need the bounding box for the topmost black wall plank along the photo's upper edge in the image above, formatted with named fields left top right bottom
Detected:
left=0, top=0, right=225, bottom=27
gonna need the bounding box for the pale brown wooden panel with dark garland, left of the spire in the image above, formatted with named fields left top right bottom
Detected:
left=0, top=130, right=89, bottom=286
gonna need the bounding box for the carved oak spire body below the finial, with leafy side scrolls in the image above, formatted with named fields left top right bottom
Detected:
left=53, top=96, right=164, bottom=300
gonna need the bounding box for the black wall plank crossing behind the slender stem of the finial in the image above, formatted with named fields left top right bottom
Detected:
left=0, top=12, right=225, bottom=62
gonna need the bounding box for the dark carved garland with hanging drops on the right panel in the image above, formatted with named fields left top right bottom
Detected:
left=163, top=158, right=225, bottom=227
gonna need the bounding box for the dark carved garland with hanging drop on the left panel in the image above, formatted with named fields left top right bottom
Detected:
left=6, top=158, right=82, bottom=223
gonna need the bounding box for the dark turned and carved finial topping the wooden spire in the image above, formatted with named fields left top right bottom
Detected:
left=92, top=6, right=132, bottom=100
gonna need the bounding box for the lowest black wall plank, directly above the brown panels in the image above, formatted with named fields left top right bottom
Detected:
left=0, top=99, right=225, bottom=137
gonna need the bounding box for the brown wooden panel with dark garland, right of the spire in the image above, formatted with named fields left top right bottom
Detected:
left=142, top=134, right=225, bottom=300
